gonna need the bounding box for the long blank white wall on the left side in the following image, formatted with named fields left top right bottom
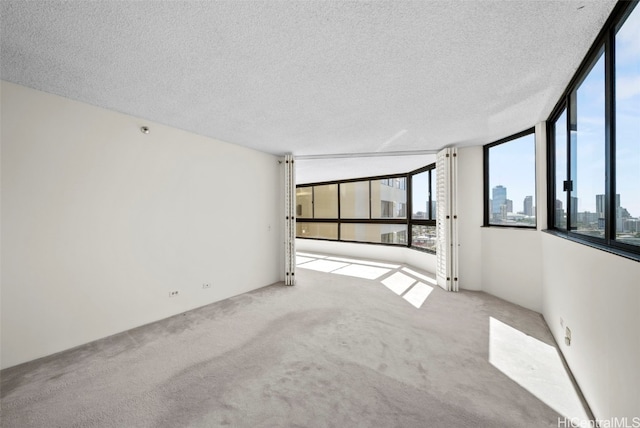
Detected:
left=1, top=82, right=282, bottom=368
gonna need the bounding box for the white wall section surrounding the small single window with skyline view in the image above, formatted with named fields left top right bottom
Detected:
left=458, top=123, right=546, bottom=312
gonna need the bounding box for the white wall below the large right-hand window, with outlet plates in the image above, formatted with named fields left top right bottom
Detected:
left=542, top=234, right=640, bottom=423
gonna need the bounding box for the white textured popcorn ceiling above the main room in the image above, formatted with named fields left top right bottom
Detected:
left=0, top=0, right=615, bottom=181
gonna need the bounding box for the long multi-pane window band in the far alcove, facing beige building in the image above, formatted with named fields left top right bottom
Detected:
left=296, top=164, right=435, bottom=252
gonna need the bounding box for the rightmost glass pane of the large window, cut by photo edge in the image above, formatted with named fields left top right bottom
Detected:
left=615, top=6, right=640, bottom=245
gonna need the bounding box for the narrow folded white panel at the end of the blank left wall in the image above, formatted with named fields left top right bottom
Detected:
left=284, top=155, right=296, bottom=285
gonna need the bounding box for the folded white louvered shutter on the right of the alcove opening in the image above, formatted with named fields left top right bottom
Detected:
left=436, top=148, right=458, bottom=291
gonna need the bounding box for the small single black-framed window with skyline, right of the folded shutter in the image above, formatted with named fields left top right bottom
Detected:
left=484, top=129, right=536, bottom=227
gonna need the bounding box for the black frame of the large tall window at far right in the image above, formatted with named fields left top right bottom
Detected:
left=545, top=1, right=640, bottom=261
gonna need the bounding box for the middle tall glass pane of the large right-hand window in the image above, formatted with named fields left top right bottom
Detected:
left=571, top=49, right=606, bottom=237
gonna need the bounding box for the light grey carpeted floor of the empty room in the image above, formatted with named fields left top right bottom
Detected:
left=0, top=254, right=592, bottom=428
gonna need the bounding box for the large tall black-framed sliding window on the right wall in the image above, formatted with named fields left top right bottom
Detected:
left=548, top=2, right=640, bottom=258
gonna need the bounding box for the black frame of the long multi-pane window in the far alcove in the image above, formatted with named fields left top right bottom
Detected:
left=296, top=162, right=436, bottom=254
